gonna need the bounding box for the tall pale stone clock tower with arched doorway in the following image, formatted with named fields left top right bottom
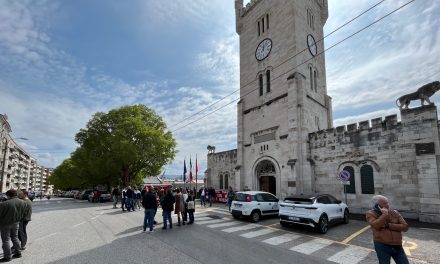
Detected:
left=234, top=0, right=332, bottom=197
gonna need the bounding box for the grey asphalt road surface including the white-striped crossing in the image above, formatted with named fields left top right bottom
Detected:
left=2, top=198, right=440, bottom=264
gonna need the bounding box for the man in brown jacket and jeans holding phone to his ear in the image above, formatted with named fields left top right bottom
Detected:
left=367, top=195, right=409, bottom=264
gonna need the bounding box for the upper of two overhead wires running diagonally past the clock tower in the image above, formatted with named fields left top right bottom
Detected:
left=172, top=0, right=416, bottom=133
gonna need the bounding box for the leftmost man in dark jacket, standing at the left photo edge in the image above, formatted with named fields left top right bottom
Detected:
left=0, top=190, right=26, bottom=262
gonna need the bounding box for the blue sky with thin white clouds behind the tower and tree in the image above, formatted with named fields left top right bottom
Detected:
left=0, top=0, right=440, bottom=176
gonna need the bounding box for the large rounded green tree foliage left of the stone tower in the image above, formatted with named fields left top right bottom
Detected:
left=53, top=105, right=176, bottom=188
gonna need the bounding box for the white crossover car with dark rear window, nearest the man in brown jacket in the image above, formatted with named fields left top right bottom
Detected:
left=279, top=194, right=349, bottom=234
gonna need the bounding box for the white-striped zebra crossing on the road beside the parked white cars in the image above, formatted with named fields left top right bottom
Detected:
left=191, top=208, right=384, bottom=264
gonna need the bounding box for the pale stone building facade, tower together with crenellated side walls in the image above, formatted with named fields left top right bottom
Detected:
left=206, top=0, right=440, bottom=223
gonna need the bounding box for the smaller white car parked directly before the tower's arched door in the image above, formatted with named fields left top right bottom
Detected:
left=231, top=191, right=279, bottom=222
